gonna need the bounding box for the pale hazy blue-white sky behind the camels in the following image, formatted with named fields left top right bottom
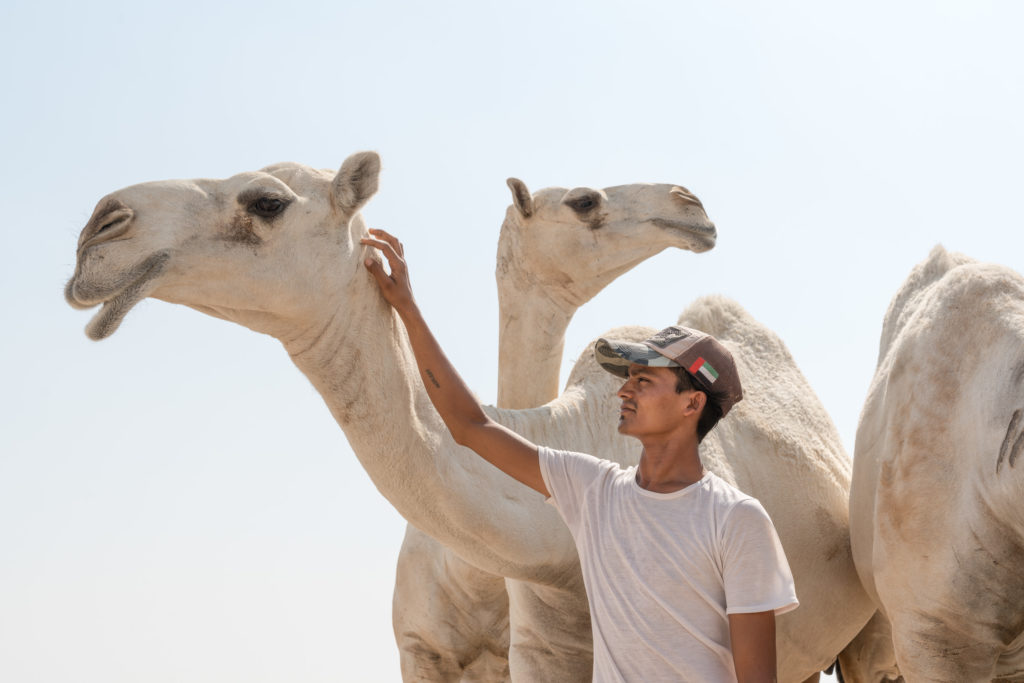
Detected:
left=0, top=0, right=1024, bottom=683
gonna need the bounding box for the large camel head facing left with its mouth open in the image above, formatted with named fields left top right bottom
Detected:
left=65, top=152, right=380, bottom=340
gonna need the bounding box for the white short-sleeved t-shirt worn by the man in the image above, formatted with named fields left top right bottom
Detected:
left=540, top=447, right=799, bottom=683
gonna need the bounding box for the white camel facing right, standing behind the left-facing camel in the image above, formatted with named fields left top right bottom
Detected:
left=392, top=178, right=716, bottom=681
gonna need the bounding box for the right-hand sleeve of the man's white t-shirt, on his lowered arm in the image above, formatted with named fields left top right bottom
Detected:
left=722, top=499, right=800, bottom=614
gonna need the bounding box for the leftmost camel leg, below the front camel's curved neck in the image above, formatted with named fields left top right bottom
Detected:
left=392, top=525, right=509, bottom=683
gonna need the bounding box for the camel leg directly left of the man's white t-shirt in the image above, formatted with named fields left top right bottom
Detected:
left=506, top=578, right=594, bottom=683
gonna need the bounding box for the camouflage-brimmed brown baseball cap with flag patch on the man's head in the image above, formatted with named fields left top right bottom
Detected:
left=594, top=326, right=743, bottom=417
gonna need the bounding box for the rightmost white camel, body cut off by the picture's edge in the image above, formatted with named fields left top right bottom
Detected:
left=850, top=247, right=1024, bottom=683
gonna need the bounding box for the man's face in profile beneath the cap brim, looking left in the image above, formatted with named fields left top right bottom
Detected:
left=618, top=364, right=702, bottom=438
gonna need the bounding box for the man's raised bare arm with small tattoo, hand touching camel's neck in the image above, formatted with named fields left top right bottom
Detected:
left=360, top=229, right=549, bottom=496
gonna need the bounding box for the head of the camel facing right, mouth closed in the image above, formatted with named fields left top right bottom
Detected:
left=498, top=178, right=717, bottom=307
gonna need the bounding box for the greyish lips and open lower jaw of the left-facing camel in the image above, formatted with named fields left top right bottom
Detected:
left=65, top=250, right=171, bottom=341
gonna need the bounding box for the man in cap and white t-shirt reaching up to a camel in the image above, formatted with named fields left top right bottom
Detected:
left=361, top=230, right=798, bottom=682
